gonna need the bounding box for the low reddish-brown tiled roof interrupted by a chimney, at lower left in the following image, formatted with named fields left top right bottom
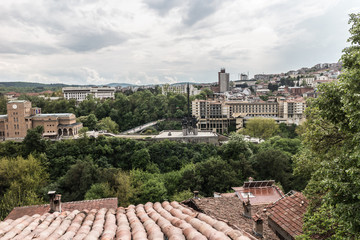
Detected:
left=5, top=198, right=118, bottom=220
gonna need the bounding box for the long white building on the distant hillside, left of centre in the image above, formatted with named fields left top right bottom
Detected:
left=62, top=87, right=115, bottom=102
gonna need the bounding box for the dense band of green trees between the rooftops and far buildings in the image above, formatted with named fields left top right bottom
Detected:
left=0, top=127, right=303, bottom=218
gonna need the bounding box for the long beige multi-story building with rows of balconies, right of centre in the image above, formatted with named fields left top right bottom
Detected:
left=192, top=98, right=306, bottom=133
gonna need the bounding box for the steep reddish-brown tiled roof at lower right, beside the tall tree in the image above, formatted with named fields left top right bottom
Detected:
left=267, top=192, right=308, bottom=238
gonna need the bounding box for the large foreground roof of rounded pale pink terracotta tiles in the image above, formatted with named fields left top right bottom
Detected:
left=0, top=202, right=249, bottom=240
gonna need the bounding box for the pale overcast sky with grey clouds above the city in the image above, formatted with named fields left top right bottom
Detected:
left=0, top=0, right=360, bottom=84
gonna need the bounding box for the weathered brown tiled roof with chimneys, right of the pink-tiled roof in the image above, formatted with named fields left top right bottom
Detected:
left=184, top=197, right=279, bottom=240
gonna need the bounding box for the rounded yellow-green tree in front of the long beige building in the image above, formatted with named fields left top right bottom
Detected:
left=243, top=117, right=279, bottom=139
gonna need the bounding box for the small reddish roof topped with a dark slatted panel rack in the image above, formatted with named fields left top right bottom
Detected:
left=232, top=180, right=284, bottom=205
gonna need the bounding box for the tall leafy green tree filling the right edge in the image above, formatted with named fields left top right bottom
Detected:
left=295, top=14, right=360, bottom=239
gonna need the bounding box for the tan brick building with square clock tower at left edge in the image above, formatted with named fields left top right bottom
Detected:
left=0, top=100, right=82, bottom=140
